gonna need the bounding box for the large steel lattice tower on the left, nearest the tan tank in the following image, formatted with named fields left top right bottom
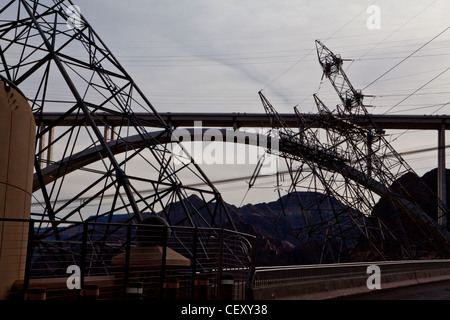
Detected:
left=0, top=0, right=234, bottom=245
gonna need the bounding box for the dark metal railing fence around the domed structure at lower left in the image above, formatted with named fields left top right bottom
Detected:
left=0, top=219, right=254, bottom=300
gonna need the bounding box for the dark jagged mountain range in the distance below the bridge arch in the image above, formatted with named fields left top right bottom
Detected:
left=34, top=169, right=450, bottom=266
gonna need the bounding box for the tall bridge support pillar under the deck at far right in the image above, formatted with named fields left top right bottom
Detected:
left=438, top=124, right=447, bottom=226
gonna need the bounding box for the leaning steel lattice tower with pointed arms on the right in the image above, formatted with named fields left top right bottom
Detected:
left=260, top=41, right=450, bottom=262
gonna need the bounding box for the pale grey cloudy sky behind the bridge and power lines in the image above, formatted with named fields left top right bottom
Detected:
left=47, top=0, right=450, bottom=204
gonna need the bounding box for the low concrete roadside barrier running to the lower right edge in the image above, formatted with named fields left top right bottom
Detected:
left=250, top=260, right=450, bottom=300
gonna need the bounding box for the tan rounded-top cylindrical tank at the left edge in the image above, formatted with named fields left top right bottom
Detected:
left=0, top=80, right=36, bottom=300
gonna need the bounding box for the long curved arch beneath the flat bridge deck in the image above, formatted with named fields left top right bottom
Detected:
left=33, top=128, right=450, bottom=252
